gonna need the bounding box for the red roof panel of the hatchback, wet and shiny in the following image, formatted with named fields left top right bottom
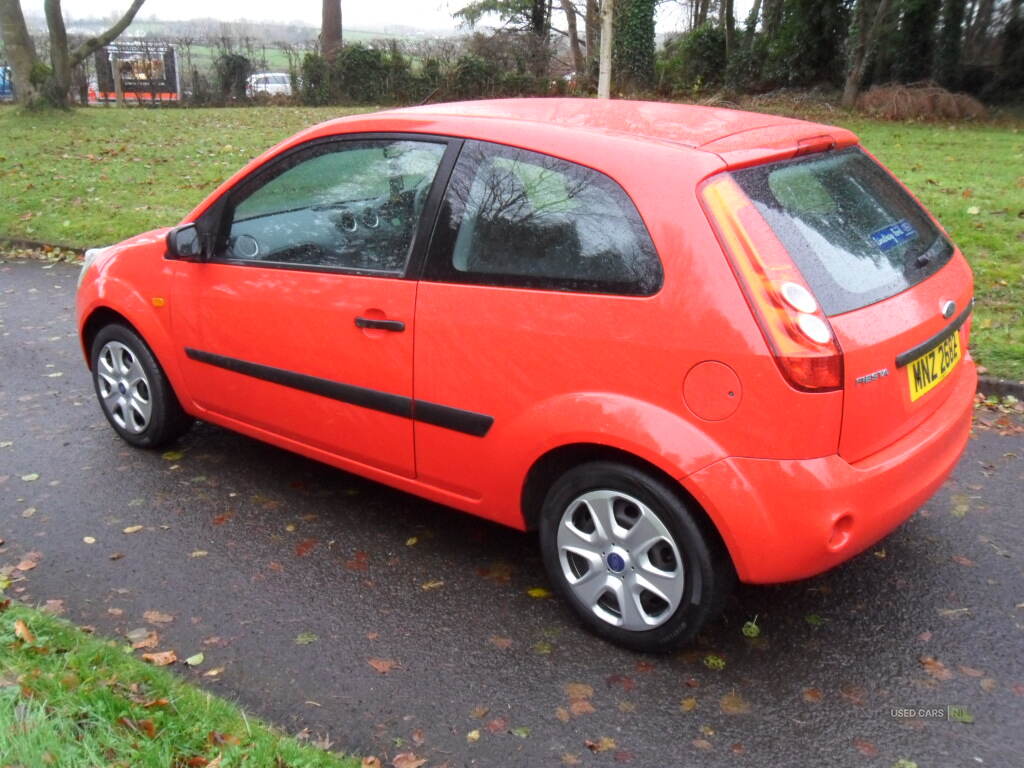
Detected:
left=362, top=98, right=839, bottom=148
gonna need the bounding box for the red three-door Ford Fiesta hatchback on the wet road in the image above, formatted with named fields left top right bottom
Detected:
left=78, top=99, right=976, bottom=650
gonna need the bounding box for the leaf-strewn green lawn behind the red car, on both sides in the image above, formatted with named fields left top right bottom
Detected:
left=0, top=106, right=1024, bottom=379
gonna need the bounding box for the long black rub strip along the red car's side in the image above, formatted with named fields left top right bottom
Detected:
left=185, top=347, right=495, bottom=437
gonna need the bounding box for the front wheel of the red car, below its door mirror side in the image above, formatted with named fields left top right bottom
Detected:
left=90, top=324, right=193, bottom=449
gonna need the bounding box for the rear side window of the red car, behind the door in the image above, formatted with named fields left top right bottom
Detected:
left=425, top=141, right=663, bottom=296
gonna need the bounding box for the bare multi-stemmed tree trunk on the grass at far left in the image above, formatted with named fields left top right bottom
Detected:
left=0, top=0, right=145, bottom=106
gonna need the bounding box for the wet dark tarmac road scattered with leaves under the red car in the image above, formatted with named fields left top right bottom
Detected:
left=0, top=261, right=1024, bottom=768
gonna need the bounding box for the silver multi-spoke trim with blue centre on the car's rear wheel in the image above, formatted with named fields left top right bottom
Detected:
left=557, top=490, right=685, bottom=632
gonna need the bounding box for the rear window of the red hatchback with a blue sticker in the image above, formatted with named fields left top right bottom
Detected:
left=733, top=148, right=953, bottom=315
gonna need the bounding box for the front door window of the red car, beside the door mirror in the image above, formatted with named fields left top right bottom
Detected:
left=218, top=139, right=445, bottom=274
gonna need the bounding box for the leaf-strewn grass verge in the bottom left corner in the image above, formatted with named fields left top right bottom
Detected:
left=0, top=602, right=359, bottom=768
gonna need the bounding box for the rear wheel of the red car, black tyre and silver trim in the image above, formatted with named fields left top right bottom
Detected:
left=540, top=461, right=736, bottom=652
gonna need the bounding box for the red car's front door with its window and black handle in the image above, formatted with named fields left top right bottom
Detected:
left=173, top=136, right=446, bottom=476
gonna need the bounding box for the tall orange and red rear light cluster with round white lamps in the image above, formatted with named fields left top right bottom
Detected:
left=700, top=174, right=843, bottom=392
